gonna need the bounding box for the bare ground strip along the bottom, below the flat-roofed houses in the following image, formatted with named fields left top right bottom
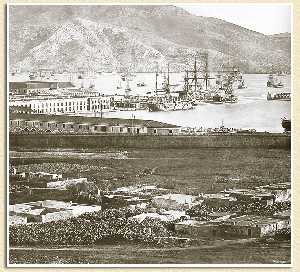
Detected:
left=9, top=241, right=291, bottom=264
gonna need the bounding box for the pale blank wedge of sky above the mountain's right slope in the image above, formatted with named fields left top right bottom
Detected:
left=177, top=4, right=291, bottom=34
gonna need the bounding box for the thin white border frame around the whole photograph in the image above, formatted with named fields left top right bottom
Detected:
left=6, top=2, right=296, bottom=268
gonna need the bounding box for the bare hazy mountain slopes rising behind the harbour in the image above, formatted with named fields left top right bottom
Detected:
left=9, top=5, right=291, bottom=72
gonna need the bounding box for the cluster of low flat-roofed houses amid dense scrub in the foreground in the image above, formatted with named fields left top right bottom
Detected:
left=9, top=167, right=291, bottom=246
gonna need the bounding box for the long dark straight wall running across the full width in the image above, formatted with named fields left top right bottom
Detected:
left=9, top=133, right=291, bottom=149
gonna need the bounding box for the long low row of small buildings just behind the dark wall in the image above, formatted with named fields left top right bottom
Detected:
left=9, top=113, right=180, bottom=135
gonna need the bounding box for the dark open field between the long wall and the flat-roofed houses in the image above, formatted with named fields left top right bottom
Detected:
left=10, top=148, right=291, bottom=194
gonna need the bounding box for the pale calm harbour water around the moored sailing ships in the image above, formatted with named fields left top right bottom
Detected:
left=86, top=74, right=291, bottom=132
